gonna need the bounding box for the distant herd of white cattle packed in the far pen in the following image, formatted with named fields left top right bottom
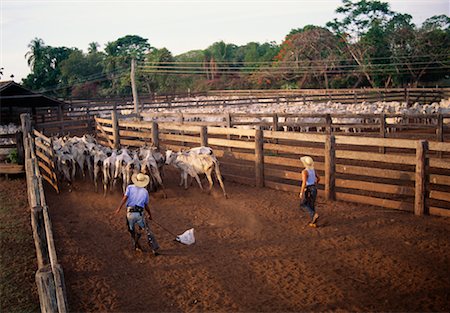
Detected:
left=130, top=97, right=450, bottom=132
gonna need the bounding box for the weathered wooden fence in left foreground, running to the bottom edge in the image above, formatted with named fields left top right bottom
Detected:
left=21, top=114, right=69, bottom=313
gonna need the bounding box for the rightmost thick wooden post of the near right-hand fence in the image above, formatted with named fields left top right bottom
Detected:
left=414, top=140, right=428, bottom=215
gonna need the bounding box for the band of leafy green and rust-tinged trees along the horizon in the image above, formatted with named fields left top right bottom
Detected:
left=23, top=0, right=450, bottom=97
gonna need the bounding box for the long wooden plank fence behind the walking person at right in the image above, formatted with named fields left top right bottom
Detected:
left=96, top=113, right=450, bottom=216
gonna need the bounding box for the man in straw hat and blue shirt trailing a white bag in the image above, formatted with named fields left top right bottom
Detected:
left=116, top=173, right=159, bottom=256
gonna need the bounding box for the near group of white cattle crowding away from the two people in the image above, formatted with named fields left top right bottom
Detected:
left=35, top=135, right=227, bottom=197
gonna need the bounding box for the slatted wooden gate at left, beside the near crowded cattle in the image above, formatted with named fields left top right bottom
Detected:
left=34, top=130, right=59, bottom=193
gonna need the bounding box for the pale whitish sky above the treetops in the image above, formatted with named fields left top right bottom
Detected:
left=0, top=0, right=450, bottom=82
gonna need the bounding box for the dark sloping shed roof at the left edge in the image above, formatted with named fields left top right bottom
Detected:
left=0, top=81, right=64, bottom=107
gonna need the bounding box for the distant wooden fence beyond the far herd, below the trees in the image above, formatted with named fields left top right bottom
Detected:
left=33, top=88, right=450, bottom=134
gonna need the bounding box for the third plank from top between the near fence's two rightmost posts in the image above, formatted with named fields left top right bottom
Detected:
left=336, top=164, right=415, bottom=181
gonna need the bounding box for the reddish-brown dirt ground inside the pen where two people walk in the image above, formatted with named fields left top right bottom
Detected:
left=42, top=171, right=450, bottom=312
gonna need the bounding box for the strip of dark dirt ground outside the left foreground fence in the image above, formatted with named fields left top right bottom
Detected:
left=0, top=175, right=39, bottom=312
